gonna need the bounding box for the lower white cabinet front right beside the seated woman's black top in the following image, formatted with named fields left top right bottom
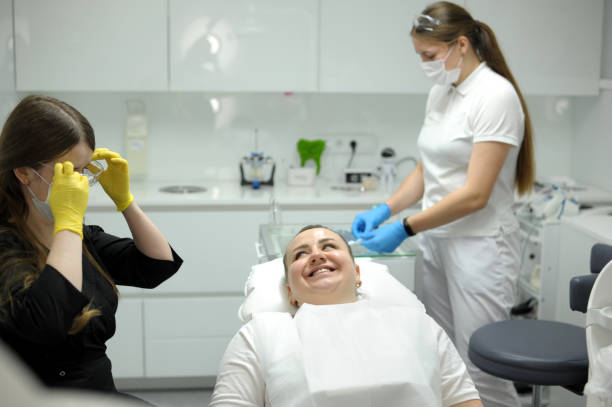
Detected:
left=106, top=298, right=145, bottom=378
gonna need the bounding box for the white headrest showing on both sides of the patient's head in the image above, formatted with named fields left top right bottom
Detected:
left=238, top=257, right=424, bottom=322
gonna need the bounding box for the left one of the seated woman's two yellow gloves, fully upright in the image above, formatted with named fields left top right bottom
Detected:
left=49, top=161, right=89, bottom=239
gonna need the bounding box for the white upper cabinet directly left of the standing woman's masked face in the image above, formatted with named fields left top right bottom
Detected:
left=319, top=0, right=432, bottom=93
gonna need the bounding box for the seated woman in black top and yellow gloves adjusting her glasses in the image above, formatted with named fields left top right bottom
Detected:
left=0, top=95, right=182, bottom=392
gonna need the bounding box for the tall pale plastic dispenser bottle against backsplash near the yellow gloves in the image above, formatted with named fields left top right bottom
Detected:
left=125, top=100, right=148, bottom=179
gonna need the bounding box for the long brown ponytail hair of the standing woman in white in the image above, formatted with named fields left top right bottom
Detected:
left=411, top=1, right=535, bottom=195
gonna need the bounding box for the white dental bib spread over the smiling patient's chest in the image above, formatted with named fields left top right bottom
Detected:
left=253, top=300, right=442, bottom=407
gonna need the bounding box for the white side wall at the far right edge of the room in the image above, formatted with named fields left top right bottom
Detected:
left=570, top=0, right=612, bottom=191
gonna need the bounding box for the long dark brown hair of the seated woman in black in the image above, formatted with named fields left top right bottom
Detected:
left=0, top=95, right=117, bottom=334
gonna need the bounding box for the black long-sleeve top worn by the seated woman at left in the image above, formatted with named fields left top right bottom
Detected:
left=0, top=225, right=183, bottom=391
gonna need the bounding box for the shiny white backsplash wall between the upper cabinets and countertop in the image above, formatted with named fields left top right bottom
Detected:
left=0, top=93, right=574, bottom=186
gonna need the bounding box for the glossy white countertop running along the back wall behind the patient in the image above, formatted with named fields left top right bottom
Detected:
left=89, top=179, right=390, bottom=210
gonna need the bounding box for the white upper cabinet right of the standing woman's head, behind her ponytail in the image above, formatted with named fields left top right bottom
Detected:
left=466, top=0, right=603, bottom=95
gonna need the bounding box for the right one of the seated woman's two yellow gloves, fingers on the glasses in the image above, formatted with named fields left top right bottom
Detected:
left=87, top=148, right=134, bottom=212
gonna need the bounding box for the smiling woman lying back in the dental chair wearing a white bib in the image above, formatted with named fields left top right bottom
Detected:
left=210, top=225, right=482, bottom=407
